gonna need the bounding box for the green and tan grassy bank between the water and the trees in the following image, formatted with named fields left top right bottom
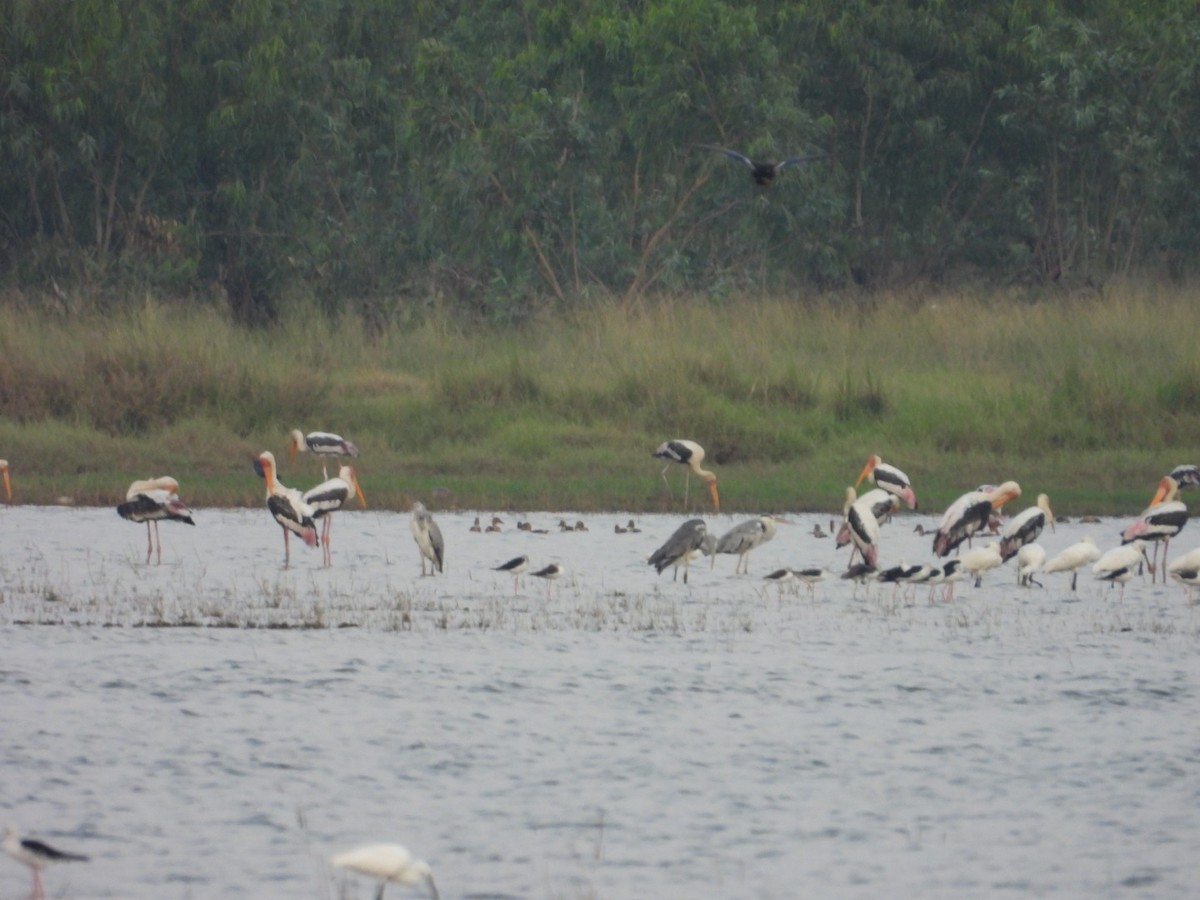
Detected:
left=0, top=284, right=1200, bottom=515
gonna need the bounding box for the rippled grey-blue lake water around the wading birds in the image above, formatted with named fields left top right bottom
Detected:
left=0, top=506, right=1200, bottom=900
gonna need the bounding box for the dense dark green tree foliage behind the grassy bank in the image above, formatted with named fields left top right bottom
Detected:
left=0, top=0, right=1200, bottom=322
